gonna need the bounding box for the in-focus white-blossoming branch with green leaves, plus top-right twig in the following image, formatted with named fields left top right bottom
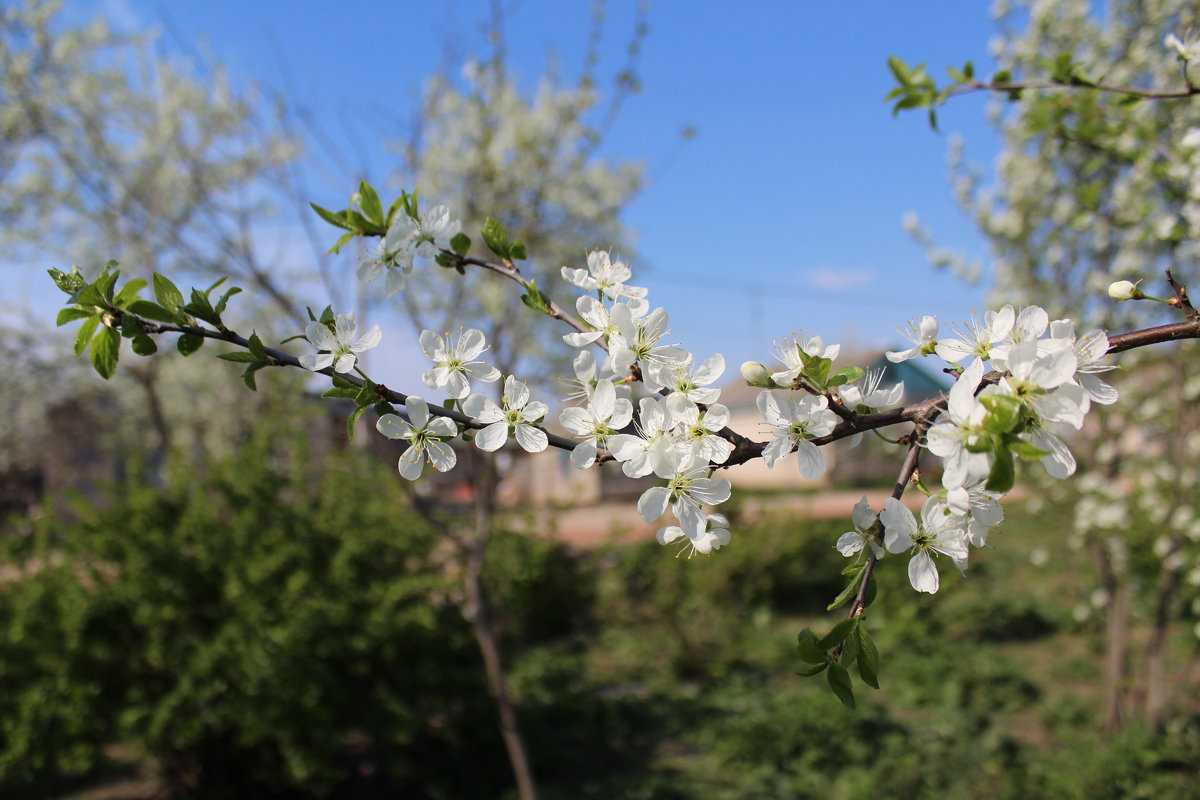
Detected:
left=50, top=32, right=1200, bottom=705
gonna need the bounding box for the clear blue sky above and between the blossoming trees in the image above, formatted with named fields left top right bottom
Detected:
left=58, top=0, right=1012, bottom=381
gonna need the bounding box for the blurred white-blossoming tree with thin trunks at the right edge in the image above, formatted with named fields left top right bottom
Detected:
left=916, top=0, right=1200, bottom=727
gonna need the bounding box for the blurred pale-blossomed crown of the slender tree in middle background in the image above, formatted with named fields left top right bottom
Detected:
left=397, top=0, right=647, bottom=380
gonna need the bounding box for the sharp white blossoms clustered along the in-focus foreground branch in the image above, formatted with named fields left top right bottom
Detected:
left=302, top=206, right=1116, bottom=593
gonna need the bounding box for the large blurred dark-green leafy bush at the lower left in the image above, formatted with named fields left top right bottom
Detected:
left=0, top=435, right=503, bottom=796
